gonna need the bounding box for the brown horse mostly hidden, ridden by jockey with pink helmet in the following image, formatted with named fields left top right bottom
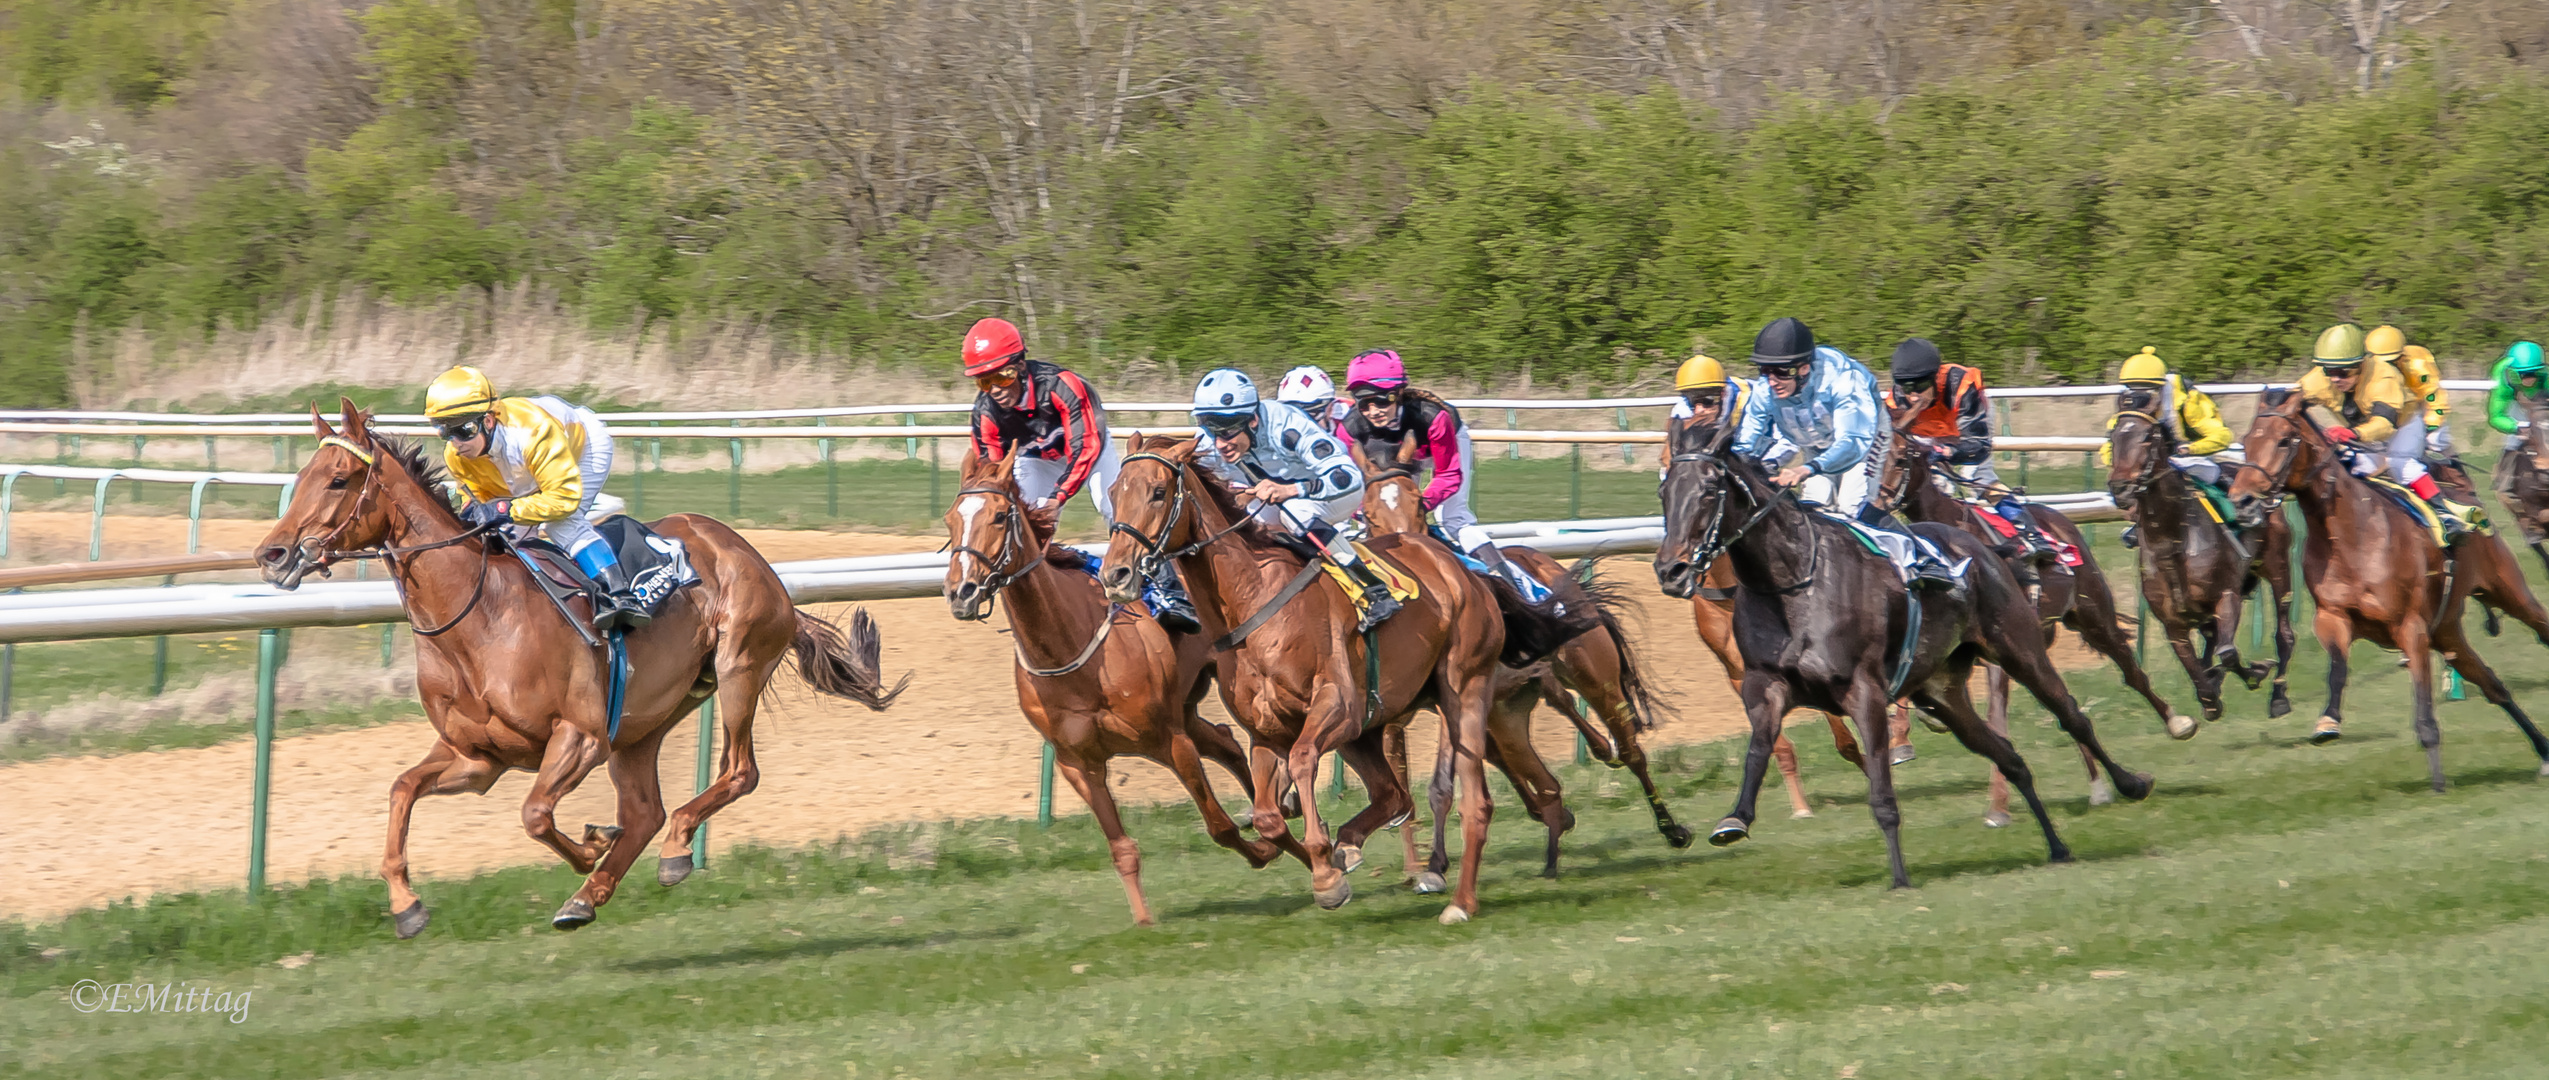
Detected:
left=1351, top=463, right=1693, bottom=892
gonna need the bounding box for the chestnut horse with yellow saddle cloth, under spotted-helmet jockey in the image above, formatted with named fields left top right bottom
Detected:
left=1099, top=436, right=1506, bottom=922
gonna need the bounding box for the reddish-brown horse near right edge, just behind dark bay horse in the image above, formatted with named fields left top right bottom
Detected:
left=2230, top=390, right=2549, bottom=792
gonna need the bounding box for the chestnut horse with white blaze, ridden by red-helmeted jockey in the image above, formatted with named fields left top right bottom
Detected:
left=946, top=451, right=1282, bottom=927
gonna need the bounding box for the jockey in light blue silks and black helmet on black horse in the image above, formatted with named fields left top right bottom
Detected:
left=1733, top=318, right=1963, bottom=588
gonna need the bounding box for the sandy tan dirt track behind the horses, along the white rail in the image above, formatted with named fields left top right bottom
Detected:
left=0, top=515, right=2083, bottom=920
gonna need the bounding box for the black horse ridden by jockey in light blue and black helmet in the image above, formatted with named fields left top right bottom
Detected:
left=1657, top=425, right=2151, bottom=889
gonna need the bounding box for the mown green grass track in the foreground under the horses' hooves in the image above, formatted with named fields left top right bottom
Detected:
left=0, top=590, right=2549, bottom=1077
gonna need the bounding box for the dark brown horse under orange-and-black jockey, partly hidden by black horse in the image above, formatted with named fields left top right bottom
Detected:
left=1874, top=413, right=2218, bottom=825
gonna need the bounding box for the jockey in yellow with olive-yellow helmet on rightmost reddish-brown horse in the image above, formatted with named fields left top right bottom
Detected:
left=2302, top=323, right=2478, bottom=543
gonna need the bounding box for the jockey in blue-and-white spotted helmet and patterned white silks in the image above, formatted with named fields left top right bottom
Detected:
left=1195, top=367, right=1399, bottom=632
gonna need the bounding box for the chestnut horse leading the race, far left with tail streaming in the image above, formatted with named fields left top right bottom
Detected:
left=257, top=400, right=910, bottom=937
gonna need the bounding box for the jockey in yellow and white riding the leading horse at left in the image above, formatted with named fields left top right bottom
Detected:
left=426, top=367, right=653, bottom=634
